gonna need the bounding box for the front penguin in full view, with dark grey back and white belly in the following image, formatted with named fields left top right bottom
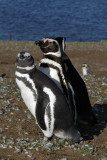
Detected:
left=15, top=52, right=80, bottom=142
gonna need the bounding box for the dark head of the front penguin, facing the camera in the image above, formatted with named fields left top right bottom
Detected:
left=16, top=52, right=35, bottom=69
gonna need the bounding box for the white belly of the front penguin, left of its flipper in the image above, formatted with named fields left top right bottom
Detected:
left=16, top=78, right=36, bottom=117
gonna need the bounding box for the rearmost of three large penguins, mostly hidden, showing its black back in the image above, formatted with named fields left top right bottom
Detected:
left=56, top=37, right=97, bottom=125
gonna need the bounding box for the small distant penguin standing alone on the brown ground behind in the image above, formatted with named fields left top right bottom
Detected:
left=82, top=63, right=92, bottom=76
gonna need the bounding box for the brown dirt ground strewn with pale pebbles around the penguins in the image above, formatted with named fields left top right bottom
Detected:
left=0, top=41, right=107, bottom=160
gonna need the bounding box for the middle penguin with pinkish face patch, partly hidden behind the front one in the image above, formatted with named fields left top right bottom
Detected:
left=35, top=38, right=77, bottom=124
